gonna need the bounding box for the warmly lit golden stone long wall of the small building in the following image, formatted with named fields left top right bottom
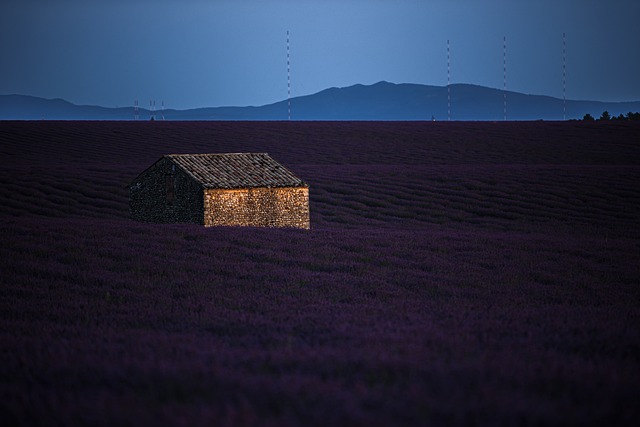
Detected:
left=204, top=187, right=310, bottom=229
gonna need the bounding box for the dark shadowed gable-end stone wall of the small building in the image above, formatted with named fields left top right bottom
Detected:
left=129, top=158, right=204, bottom=224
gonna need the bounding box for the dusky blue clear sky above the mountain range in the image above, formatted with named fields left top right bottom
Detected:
left=0, top=0, right=640, bottom=109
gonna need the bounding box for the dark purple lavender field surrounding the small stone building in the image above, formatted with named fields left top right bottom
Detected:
left=0, top=122, right=640, bottom=426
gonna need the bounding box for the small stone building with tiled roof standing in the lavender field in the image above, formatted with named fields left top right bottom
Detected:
left=129, top=153, right=310, bottom=229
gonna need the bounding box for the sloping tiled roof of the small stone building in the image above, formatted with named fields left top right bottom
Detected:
left=164, top=153, right=306, bottom=188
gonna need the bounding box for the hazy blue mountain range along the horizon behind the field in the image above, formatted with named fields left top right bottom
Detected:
left=0, top=82, right=640, bottom=120
